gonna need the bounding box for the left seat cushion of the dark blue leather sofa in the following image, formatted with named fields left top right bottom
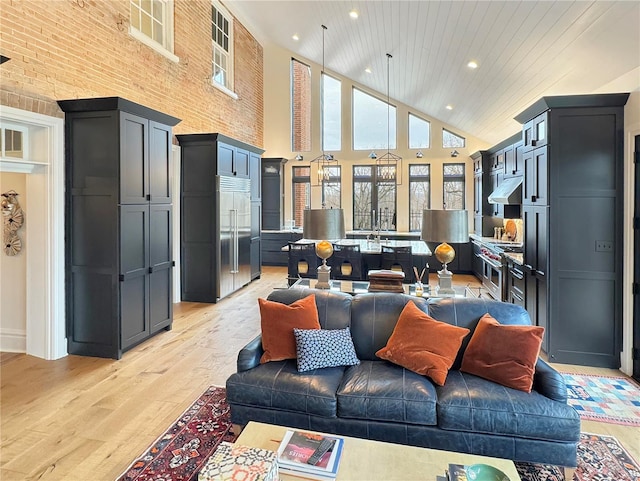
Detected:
left=227, top=360, right=345, bottom=417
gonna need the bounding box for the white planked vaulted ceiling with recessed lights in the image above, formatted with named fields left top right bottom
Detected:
left=224, top=0, right=640, bottom=144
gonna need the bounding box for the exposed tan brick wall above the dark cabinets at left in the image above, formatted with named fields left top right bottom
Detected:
left=0, top=0, right=264, bottom=147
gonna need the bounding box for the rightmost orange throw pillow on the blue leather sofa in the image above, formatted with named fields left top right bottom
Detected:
left=460, top=314, right=544, bottom=392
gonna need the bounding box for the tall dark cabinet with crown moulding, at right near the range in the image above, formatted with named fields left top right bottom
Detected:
left=516, top=94, right=629, bottom=368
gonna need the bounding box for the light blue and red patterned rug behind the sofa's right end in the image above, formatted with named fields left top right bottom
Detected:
left=562, top=373, right=640, bottom=426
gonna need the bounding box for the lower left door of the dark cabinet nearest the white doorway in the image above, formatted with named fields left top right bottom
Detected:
left=120, top=205, right=151, bottom=349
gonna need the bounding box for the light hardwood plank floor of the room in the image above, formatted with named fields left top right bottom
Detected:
left=0, top=267, right=640, bottom=481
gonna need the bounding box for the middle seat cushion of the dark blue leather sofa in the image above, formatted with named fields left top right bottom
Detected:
left=337, top=361, right=436, bottom=425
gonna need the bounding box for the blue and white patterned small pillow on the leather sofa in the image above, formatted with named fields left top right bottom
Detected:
left=293, top=327, right=360, bottom=372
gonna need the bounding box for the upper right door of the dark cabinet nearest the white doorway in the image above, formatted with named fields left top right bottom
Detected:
left=149, top=121, right=172, bottom=204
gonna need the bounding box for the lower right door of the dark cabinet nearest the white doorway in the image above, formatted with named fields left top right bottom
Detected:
left=148, top=204, right=173, bottom=333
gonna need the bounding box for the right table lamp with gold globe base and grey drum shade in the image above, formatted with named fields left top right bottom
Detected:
left=420, top=209, right=469, bottom=295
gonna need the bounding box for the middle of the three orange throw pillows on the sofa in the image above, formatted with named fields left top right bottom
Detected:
left=376, top=301, right=469, bottom=386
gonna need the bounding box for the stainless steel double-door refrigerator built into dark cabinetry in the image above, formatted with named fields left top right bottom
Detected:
left=215, top=175, right=251, bottom=299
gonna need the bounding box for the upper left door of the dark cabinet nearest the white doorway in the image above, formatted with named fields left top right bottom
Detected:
left=120, top=112, right=149, bottom=204
